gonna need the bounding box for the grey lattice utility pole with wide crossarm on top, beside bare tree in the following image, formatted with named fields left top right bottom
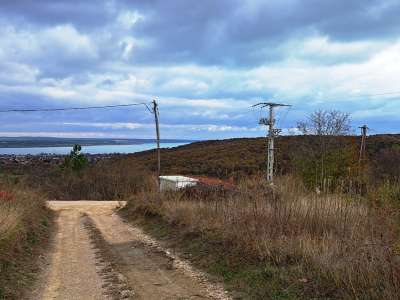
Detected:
left=253, top=102, right=291, bottom=183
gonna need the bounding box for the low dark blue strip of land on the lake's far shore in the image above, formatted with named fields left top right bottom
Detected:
left=0, top=137, right=192, bottom=148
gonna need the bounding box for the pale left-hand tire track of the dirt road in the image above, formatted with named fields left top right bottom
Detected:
left=29, top=206, right=107, bottom=300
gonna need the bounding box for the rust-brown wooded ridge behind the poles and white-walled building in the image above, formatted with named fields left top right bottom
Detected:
left=123, top=134, right=400, bottom=178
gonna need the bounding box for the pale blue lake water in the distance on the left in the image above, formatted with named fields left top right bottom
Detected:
left=0, top=143, right=188, bottom=155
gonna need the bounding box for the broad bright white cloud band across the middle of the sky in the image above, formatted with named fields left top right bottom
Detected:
left=2, top=36, right=400, bottom=113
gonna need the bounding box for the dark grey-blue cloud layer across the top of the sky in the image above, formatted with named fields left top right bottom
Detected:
left=0, top=0, right=400, bottom=71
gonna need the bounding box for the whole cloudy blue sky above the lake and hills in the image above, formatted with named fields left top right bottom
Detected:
left=0, top=0, right=400, bottom=140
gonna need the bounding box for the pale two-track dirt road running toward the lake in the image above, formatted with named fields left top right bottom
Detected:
left=30, top=201, right=229, bottom=300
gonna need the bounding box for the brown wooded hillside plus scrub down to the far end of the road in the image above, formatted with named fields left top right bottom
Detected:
left=11, top=135, right=400, bottom=200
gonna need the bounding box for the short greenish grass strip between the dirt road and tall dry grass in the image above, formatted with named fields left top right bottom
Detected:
left=120, top=210, right=308, bottom=299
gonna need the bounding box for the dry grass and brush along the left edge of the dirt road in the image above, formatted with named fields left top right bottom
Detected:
left=0, top=179, right=51, bottom=299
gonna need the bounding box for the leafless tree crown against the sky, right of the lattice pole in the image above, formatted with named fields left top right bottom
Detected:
left=297, top=109, right=351, bottom=136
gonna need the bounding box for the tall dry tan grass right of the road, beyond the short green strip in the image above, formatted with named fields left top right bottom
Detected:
left=129, top=177, right=400, bottom=299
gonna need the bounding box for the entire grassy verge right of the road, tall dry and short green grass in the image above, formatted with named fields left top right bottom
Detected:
left=123, top=178, right=400, bottom=299
